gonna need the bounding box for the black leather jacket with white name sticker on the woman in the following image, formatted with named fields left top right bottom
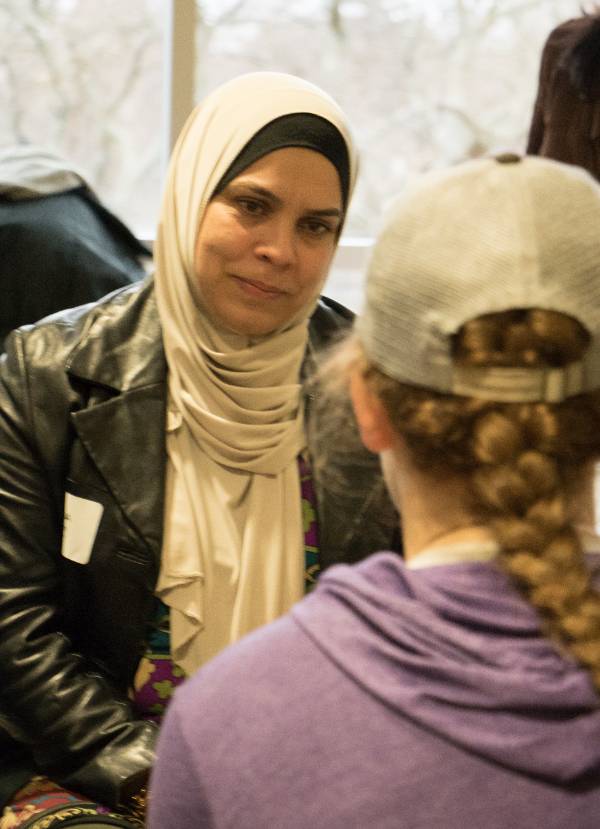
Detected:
left=0, top=279, right=396, bottom=805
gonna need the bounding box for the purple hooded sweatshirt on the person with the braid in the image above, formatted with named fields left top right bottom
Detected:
left=149, top=553, right=600, bottom=829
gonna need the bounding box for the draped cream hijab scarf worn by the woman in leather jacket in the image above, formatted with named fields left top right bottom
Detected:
left=154, top=72, right=356, bottom=674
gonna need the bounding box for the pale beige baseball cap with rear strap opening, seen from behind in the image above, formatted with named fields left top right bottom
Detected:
left=356, top=153, right=600, bottom=402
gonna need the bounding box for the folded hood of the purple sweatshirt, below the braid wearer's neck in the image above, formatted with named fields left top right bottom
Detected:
left=292, top=553, right=600, bottom=783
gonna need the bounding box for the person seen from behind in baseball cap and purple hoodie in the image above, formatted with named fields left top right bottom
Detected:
left=149, top=155, right=600, bottom=829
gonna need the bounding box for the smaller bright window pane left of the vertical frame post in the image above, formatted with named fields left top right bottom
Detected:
left=0, top=0, right=165, bottom=233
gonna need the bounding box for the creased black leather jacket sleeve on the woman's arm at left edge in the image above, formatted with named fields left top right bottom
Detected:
left=0, top=326, right=157, bottom=806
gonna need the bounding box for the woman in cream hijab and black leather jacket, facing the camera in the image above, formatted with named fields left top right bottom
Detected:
left=0, top=73, right=397, bottom=829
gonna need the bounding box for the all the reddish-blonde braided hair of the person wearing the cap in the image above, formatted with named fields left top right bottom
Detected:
left=359, top=310, right=600, bottom=691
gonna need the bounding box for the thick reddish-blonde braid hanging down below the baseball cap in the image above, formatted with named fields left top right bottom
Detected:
left=471, top=406, right=600, bottom=690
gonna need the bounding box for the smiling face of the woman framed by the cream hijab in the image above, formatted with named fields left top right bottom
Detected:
left=194, top=147, right=342, bottom=337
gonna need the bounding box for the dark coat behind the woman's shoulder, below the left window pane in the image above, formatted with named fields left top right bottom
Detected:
left=0, top=186, right=150, bottom=351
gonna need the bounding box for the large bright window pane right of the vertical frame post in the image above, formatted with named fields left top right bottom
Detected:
left=196, top=0, right=581, bottom=237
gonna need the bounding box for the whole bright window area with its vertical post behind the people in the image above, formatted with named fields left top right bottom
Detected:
left=0, top=0, right=581, bottom=307
